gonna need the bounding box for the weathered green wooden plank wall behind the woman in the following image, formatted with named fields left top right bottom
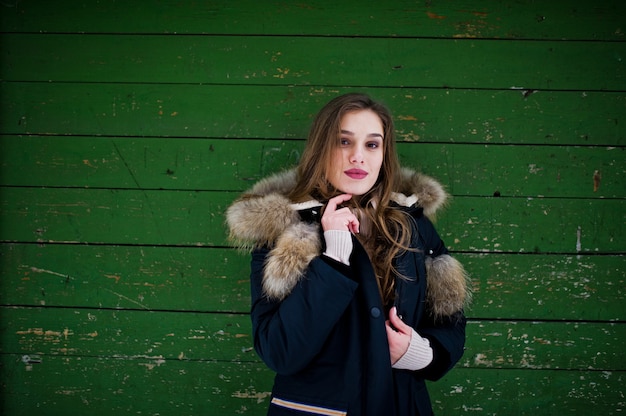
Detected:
left=0, top=0, right=626, bottom=416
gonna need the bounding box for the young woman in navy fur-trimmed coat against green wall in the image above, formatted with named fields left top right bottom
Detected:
left=227, top=94, right=468, bottom=416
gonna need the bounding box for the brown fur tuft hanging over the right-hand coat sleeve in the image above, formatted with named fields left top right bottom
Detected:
left=426, top=254, right=472, bottom=319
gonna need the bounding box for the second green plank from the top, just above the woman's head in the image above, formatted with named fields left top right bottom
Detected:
left=0, top=34, right=626, bottom=91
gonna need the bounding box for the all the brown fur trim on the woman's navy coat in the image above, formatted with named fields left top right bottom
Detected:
left=226, top=168, right=469, bottom=316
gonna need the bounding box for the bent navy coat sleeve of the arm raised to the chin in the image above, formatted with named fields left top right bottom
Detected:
left=251, top=249, right=358, bottom=375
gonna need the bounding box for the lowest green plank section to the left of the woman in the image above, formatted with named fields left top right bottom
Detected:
left=0, top=354, right=273, bottom=416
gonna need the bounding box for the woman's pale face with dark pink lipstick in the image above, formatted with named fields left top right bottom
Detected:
left=327, top=110, right=384, bottom=195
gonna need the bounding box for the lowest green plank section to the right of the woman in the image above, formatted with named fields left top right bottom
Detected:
left=428, top=368, right=626, bottom=416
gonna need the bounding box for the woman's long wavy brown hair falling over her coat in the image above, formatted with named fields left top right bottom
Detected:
left=289, top=93, right=410, bottom=304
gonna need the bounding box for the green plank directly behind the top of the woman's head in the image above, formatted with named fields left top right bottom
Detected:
left=0, top=83, right=626, bottom=146
